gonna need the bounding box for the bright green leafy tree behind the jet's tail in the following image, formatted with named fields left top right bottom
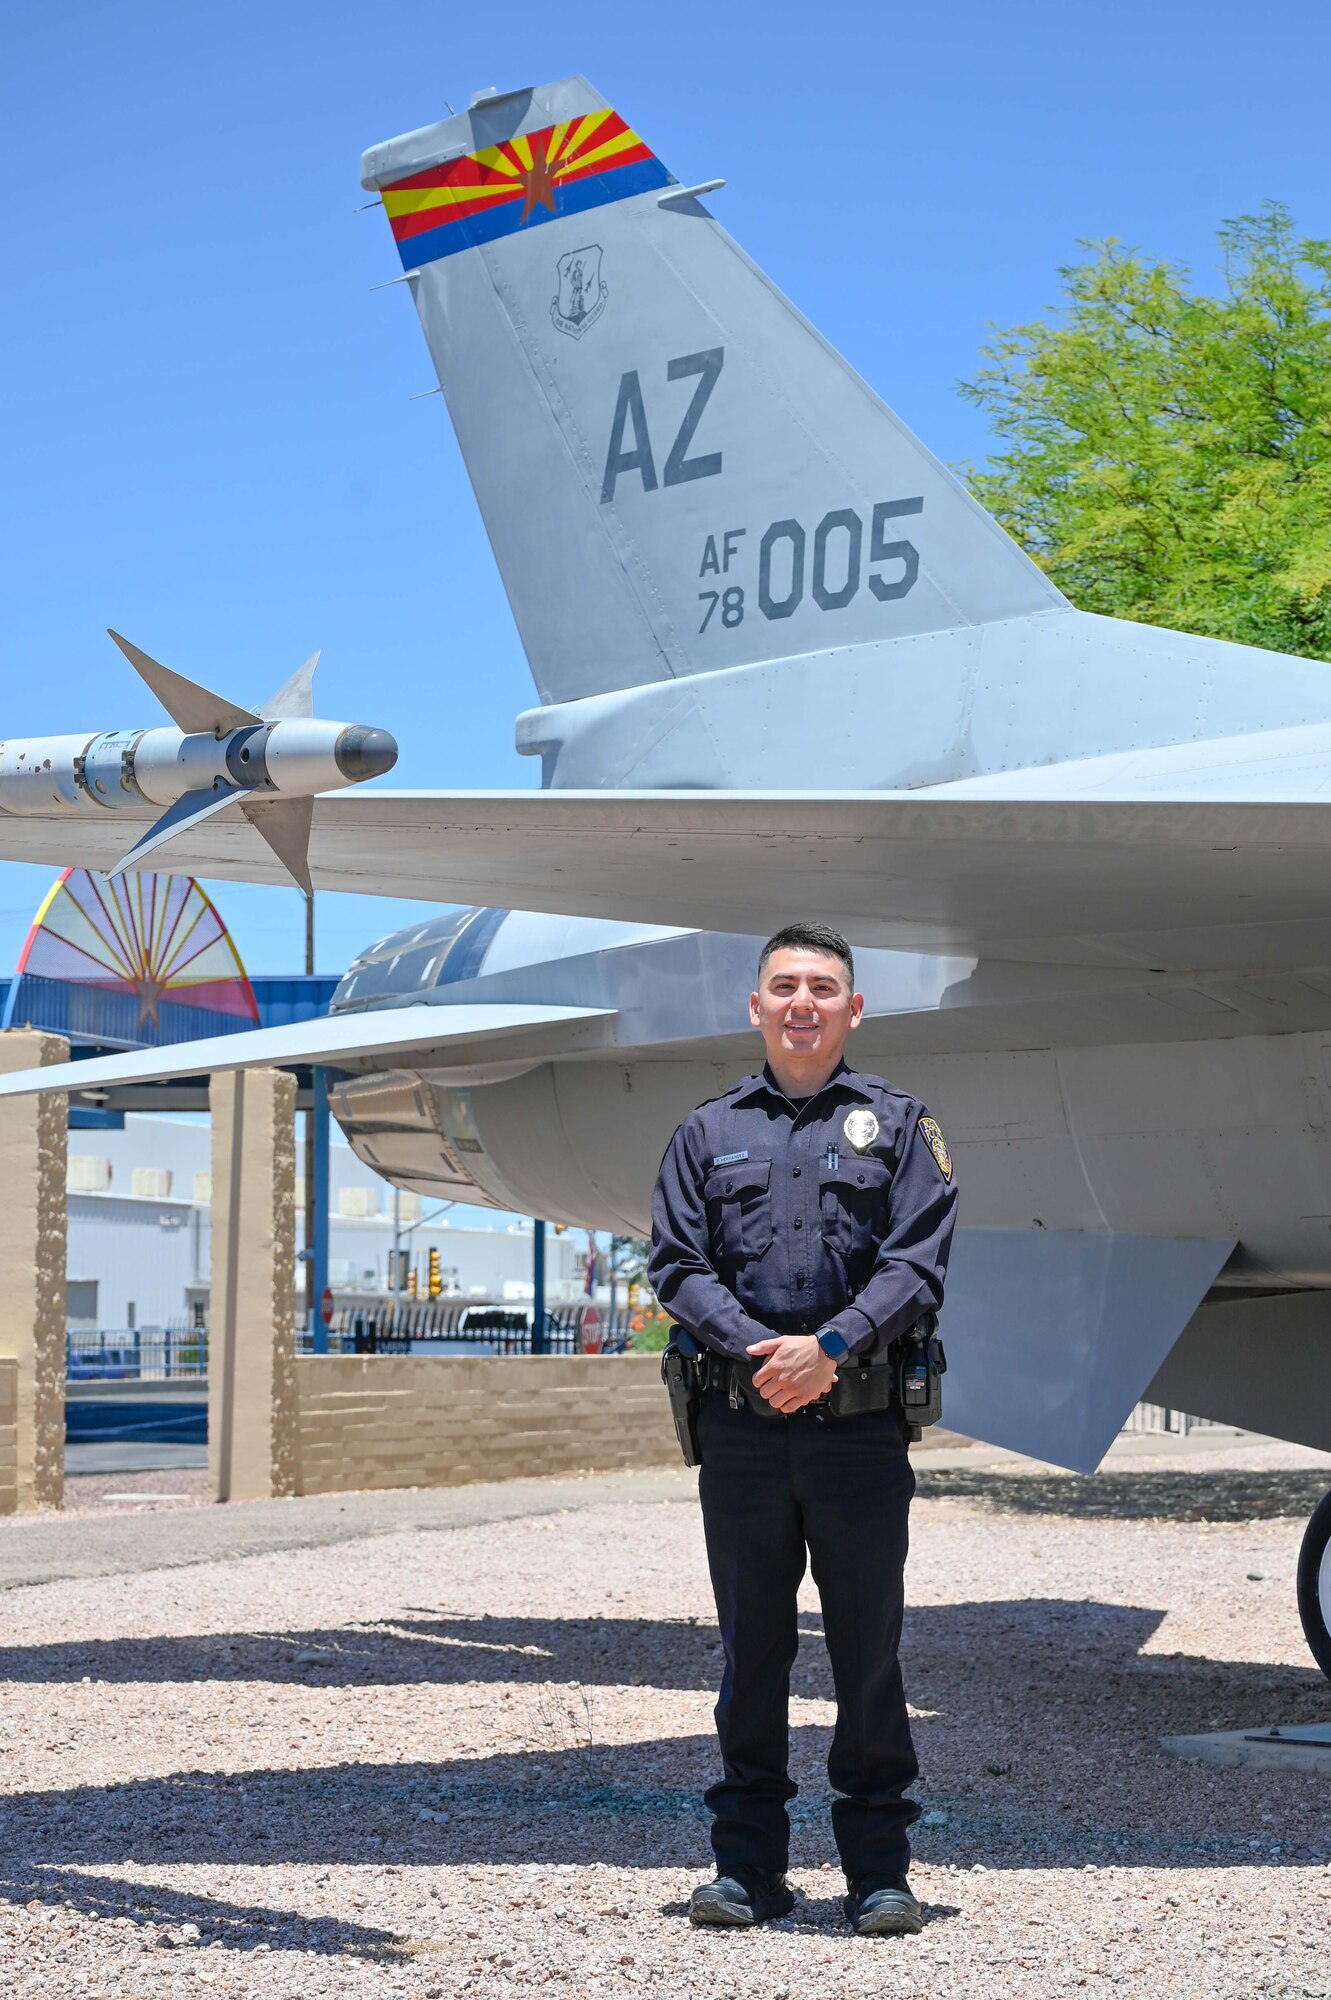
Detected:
left=961, top=204, right=1331, bottom=660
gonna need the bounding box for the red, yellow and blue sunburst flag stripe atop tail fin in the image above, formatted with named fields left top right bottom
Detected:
left=384, top=110, right=671, bottom=262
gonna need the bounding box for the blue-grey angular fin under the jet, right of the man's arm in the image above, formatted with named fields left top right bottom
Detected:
left=941, top=1228, right=1233, bottom=1472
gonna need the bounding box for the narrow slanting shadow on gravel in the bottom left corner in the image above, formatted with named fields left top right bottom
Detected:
left=0, top=1864, right=410, bottom=1970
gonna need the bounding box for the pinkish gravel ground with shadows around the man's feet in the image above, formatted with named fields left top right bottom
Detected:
left=0, top=1444, right=1331, bottom=2000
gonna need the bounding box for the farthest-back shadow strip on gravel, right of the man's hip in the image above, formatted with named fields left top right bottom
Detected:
left=915, top=1458, right=1329, bottom=1522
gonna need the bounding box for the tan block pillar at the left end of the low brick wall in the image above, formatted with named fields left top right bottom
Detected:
left=208, top=1070, right=298, bottom=1500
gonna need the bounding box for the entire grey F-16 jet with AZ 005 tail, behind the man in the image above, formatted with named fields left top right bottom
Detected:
left=0, top=78, right=1331, bottom=1672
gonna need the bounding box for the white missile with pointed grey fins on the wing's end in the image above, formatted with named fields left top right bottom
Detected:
left=0, top=632, right=398, bottom=892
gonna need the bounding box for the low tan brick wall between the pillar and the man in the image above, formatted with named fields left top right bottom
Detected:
left=296, top=1354, right=679, bottom=1494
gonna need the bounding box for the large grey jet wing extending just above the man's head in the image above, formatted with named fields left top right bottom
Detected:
left=0, top=724, right=1331, bottom=970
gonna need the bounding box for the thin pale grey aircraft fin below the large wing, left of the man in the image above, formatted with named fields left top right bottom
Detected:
left=0, top=1006, right=614, bottom=1098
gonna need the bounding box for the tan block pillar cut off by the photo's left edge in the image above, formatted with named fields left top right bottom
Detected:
left=0, top=1028, right=70, bottom=1508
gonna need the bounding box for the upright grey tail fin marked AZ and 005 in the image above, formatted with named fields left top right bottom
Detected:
left=362, top=76, right=1065, bottom=702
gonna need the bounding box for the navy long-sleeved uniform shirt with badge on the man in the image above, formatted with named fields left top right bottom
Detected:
left=648, top=1064, right=957, bottom=1360
